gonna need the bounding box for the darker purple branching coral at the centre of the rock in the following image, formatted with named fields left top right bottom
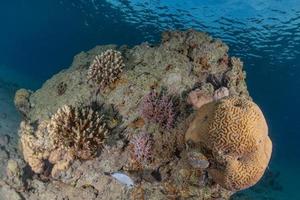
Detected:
left=140, top=91, right=176, bottom=129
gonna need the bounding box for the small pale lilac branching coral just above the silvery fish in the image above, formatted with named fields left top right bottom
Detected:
left=130, top=132, right=153, bottom=163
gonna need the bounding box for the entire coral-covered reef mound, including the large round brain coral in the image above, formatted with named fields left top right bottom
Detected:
left=10, top=30, right=272, bottom=199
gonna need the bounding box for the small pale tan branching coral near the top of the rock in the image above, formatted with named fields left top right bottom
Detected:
left=88, top=49, right=124, bottom=89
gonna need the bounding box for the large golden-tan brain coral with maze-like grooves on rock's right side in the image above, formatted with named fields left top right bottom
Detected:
left=185, top=97, right=272, bottom=191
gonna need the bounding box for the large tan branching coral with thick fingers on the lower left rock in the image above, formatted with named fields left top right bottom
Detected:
left=48, top=105, right=108, bottom=159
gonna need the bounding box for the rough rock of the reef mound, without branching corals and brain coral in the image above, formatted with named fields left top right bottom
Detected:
left=11, top=30, right=255, bottom=200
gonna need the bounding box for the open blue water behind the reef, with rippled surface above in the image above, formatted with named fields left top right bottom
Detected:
left=0, top=0, right=300, bottom=200
